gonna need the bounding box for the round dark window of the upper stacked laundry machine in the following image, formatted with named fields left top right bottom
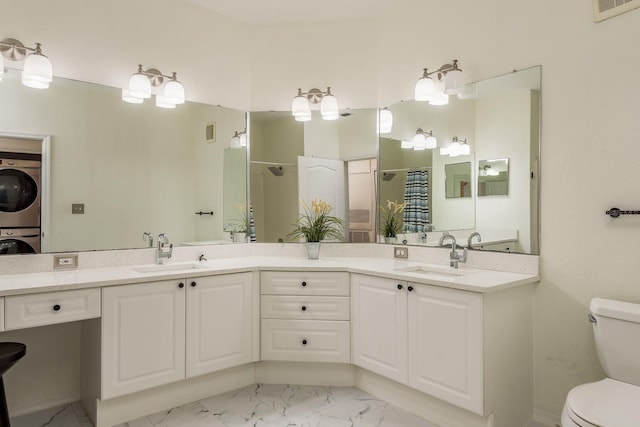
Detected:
left=0, top=169, right=38, bottom=212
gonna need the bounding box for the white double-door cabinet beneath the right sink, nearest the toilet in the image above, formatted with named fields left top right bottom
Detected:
left=351, top=274, right=484, bottom=414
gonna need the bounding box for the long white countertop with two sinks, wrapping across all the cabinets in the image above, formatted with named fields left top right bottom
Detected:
left=0, top=256, right=539, bottom=296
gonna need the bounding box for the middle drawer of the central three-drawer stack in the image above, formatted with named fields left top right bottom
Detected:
left=260, top=295, right=350, bottom=320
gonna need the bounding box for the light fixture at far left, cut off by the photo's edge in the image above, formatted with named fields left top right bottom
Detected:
left=0, top=39, right=53, bottom=89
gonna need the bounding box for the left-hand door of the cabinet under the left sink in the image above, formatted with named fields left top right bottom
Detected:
left=102, top=280, right=186, bottom=399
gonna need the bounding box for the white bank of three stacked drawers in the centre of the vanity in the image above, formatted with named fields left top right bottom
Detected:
left=260, top=271, right=351, bottom=363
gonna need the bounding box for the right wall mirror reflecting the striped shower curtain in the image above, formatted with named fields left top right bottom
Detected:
left=378, top=67, right=540, bottom=254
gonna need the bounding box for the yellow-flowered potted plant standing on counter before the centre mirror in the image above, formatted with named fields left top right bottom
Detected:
left=287, top=199, right=344, bottom=259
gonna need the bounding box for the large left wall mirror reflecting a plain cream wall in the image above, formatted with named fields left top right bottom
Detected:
left=0, top=70, right=246, bottom=252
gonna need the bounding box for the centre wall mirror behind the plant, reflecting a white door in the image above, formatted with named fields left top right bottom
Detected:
left=249, top=109, right=377, bottom=242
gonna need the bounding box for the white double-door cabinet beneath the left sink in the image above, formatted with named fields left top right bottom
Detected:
left=101, top=273, right=253, bottom=400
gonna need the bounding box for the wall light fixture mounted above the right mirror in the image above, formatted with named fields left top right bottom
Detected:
left=414, top=59, right=462, bottom=105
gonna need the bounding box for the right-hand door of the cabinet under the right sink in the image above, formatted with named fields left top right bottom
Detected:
left=409, top=284, right=483, bottom=414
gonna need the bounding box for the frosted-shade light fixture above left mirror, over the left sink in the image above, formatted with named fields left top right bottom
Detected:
left=122, top=65, right=185, bottom=108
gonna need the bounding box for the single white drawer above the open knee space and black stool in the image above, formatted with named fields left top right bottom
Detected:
left=5, top=289, right=100, bottom=330
